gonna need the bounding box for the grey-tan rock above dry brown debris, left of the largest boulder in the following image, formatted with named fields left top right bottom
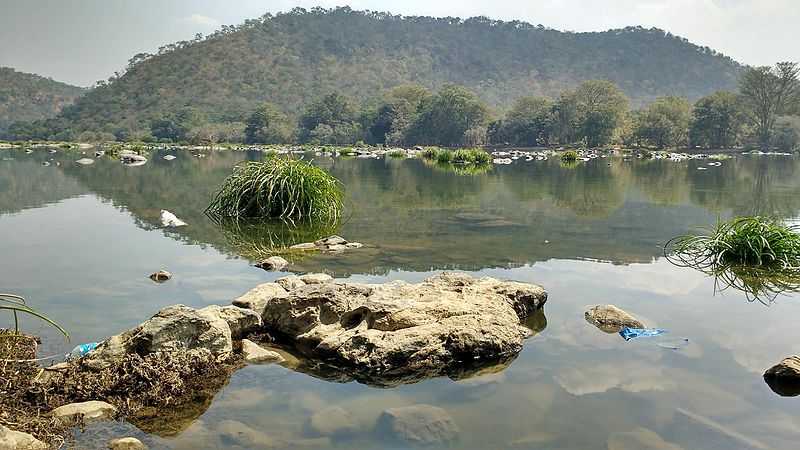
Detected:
left=81, top=305, right=241, bottom=370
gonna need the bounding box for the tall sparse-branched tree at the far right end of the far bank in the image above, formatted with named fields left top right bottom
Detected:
left=739, top=62, right=800, bottom=149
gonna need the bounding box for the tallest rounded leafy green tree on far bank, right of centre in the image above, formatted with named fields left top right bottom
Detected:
left=574, top=80, right=628, bottom=147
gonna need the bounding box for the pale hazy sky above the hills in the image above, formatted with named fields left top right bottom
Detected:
left=0, top=0, right=800, bottom=86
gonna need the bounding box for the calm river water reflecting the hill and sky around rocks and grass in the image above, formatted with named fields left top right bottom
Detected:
left=0, top=150, right=800, bottom=450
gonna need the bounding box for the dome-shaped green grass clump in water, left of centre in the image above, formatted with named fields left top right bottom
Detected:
left=206, top=157, right=344, bottom=223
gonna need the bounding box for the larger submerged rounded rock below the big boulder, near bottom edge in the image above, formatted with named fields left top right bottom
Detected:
left=376, top=404, right=459, bottom=445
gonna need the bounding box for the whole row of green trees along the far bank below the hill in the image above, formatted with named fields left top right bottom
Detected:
left=6, top=63, right=800, bottom=150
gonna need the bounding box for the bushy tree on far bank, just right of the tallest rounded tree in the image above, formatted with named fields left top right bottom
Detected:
left=635, top=97, right=692, bottom=148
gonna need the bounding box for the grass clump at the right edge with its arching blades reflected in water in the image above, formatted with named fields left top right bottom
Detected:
left=664, top=216, right=800, bottom=304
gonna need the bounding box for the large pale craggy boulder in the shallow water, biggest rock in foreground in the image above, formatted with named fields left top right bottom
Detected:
left=248, top=273, right=547, bottom=384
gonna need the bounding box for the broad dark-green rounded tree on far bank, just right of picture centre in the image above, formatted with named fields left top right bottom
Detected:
left=409, top=84, right=489, bottom=145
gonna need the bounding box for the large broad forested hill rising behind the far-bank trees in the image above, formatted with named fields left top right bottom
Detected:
left=43, top=8, right=741, bottom=132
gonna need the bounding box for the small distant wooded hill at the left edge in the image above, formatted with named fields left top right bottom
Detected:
left=0, top=67, right=84, bottom=131
